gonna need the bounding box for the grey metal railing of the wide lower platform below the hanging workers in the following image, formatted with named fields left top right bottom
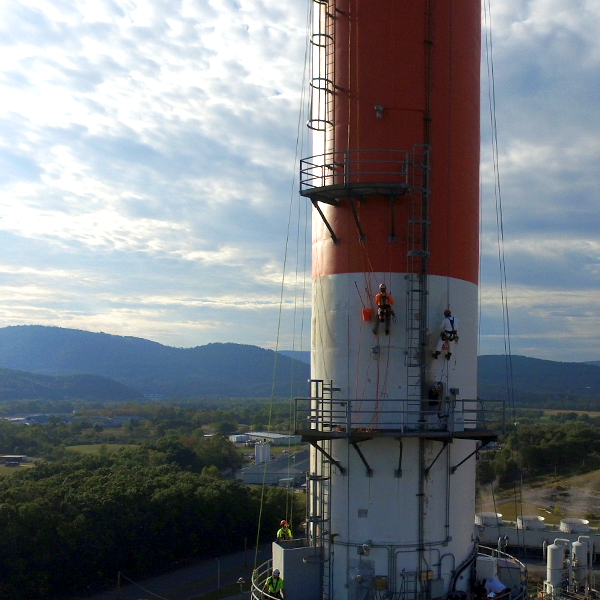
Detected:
left=294, top=398, right=505, bottom=438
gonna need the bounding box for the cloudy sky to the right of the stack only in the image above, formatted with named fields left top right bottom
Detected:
left=480, top=0, right=600, bottom=361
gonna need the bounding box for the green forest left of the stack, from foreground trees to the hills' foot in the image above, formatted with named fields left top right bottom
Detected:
left=0, top=401, right=304, bottom=600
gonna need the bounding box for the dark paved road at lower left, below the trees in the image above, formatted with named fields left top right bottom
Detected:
left=80, top=544, right=271, bottom=600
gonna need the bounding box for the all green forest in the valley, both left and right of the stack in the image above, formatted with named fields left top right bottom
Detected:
left=0, top=398, right=600, bottom=600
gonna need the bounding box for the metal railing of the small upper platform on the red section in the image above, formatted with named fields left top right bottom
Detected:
left=300, top=150, right=410, bottom=196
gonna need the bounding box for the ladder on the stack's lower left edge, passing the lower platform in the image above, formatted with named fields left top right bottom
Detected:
left=306, top=379, right=336, bottom=600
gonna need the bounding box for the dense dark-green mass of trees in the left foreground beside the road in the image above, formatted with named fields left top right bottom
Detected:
left=0, top=436, right=301, bottom=600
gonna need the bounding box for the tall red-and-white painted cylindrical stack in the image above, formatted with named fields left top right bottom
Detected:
left=305, top=0, right=481, bottom=600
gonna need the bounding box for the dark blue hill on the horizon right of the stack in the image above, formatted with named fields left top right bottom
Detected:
left=478, top=355, right=600, bottom=400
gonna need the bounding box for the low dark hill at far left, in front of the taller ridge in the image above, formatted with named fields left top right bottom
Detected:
left=0, top=369, right=143, bottom=400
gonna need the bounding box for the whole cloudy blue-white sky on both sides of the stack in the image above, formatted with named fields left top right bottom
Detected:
left=0, top=0, right=600, bottom=361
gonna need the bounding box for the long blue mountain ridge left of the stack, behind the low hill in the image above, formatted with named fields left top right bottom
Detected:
left=0, top=325, right=310, bottom=397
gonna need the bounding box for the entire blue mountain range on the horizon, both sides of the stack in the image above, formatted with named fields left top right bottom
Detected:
left=0, top=325, right=600, bottom=405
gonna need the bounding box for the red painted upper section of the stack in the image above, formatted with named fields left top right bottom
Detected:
left=313, top=0, right=481, bottom=284
